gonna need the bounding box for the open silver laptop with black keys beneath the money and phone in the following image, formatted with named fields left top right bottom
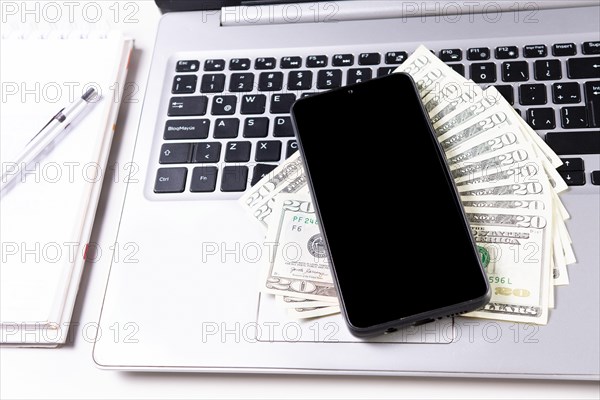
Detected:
left=93, top=0, right=600, bottom=380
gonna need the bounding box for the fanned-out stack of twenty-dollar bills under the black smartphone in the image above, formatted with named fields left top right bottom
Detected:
left=240, top=46, right=575, bottom=324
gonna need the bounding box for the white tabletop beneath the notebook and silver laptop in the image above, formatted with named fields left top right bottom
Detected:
left=0, top=1, right=600, bottom=399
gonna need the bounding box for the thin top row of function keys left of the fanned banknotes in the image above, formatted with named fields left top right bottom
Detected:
left=176, top=51, right=408, bottom=72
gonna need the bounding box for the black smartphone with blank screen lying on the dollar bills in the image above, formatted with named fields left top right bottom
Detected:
left=292, top=73, right=490, bottom=336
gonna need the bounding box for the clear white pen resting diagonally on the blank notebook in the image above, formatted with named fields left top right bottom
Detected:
left=0, top=88, right=96, bottom=192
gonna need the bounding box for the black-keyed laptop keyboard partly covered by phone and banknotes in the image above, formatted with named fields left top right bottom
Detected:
left=154, top=41, right=600, bottom=196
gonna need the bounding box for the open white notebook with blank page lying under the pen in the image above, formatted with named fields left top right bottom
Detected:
left=0, top=33, right=133, bottom=346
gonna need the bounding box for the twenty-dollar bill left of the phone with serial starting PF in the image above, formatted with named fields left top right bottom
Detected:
left=260, top=194, right=337, bottom=302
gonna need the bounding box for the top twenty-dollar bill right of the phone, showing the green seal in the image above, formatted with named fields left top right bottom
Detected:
left=465, top=208, right=552, bottom=325
